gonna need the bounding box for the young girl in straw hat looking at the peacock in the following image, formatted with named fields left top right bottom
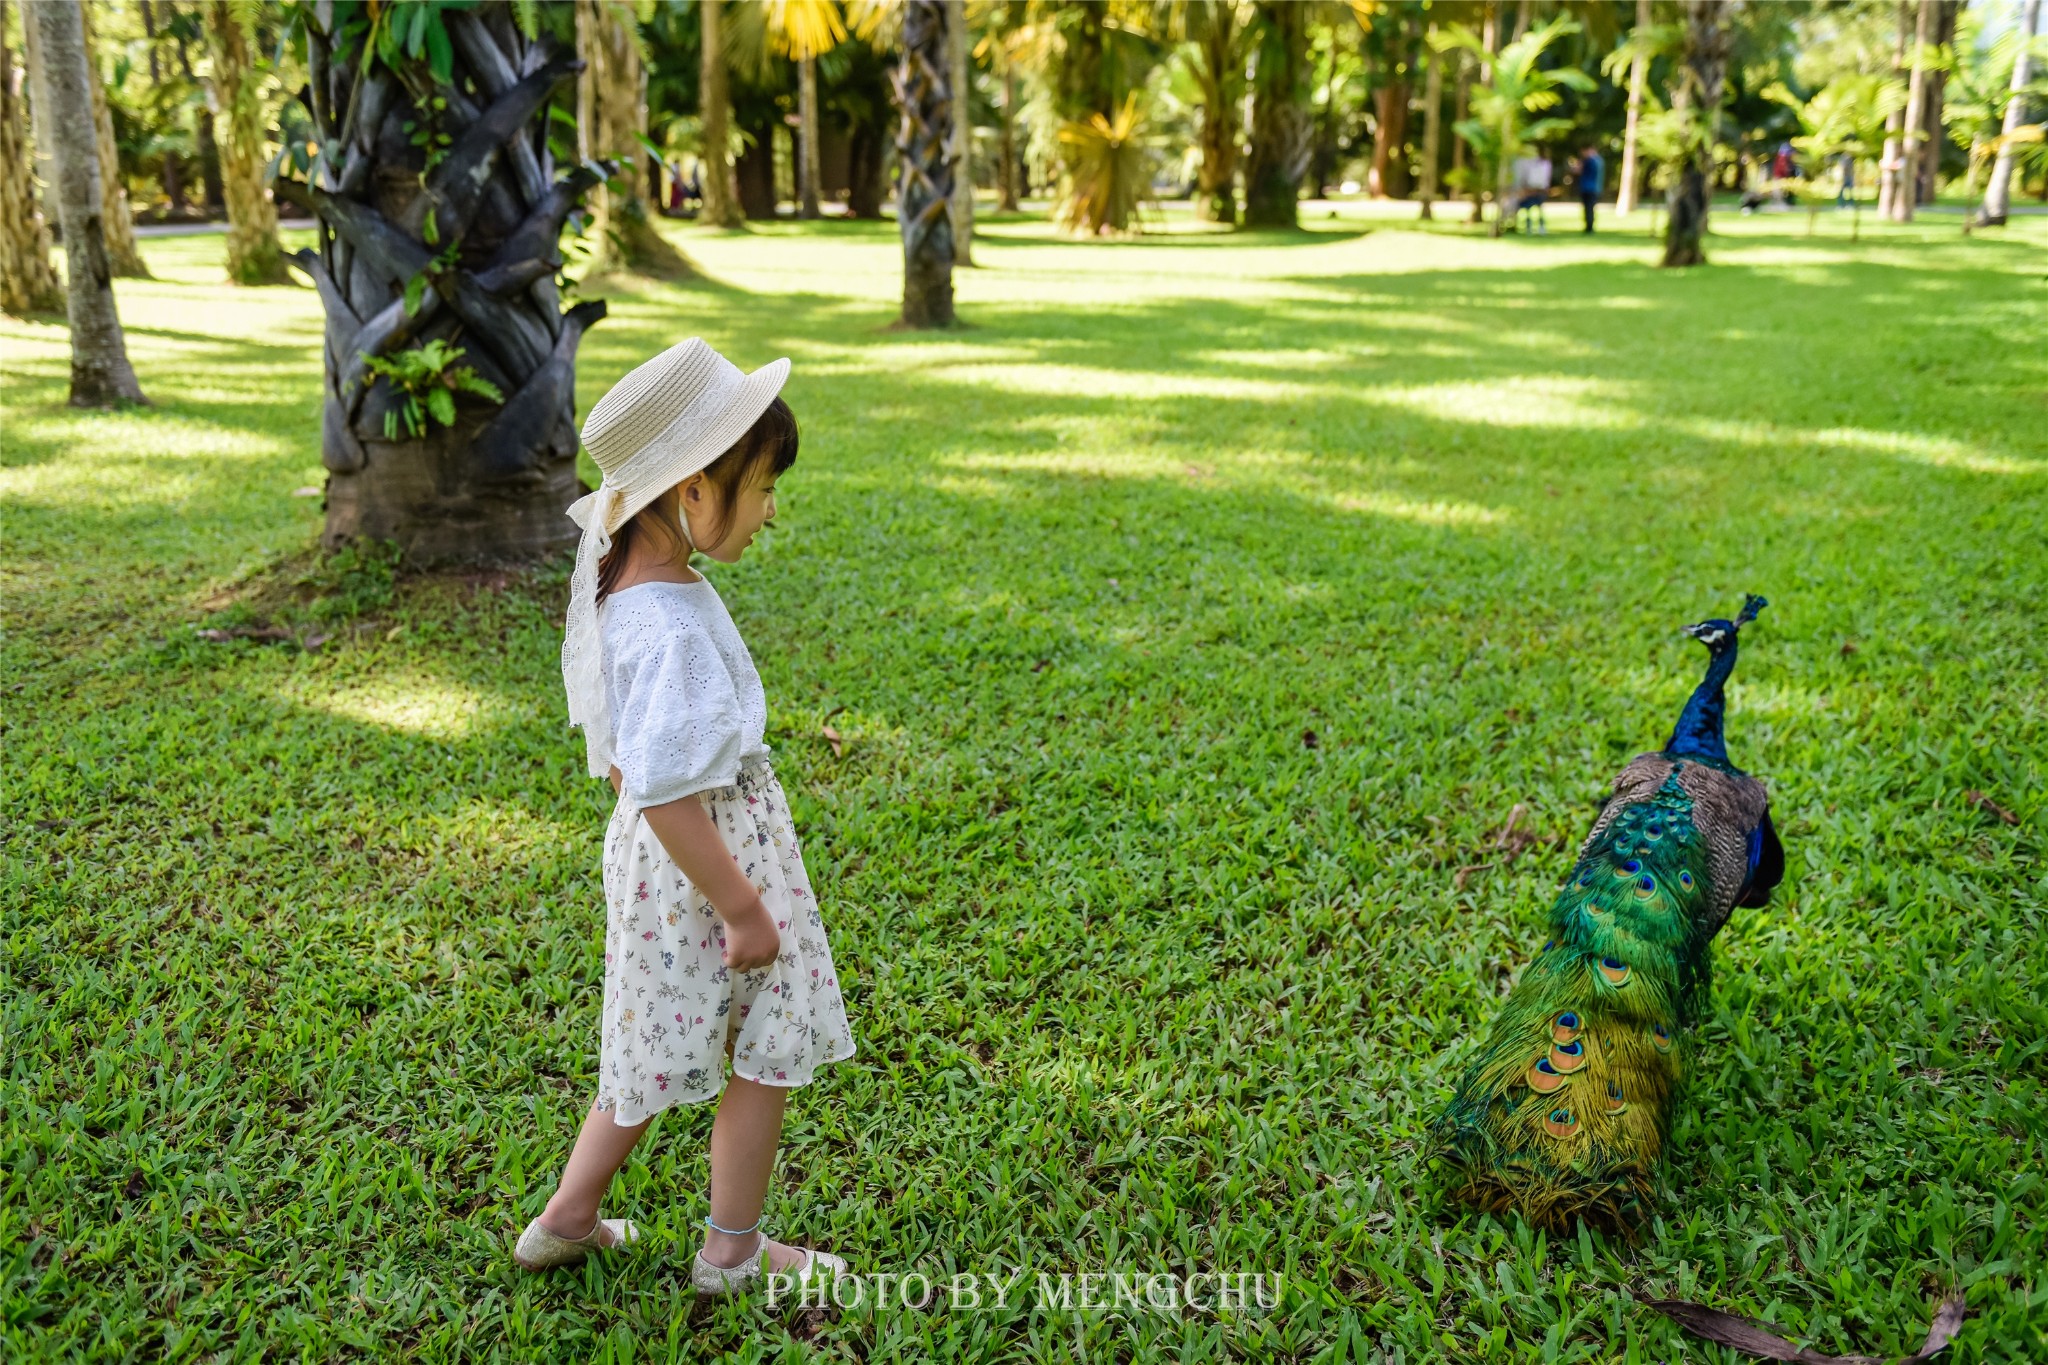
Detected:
left=512, top=338, right=854, bottom=1293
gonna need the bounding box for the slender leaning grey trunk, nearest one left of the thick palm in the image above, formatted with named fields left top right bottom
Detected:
left=23, top=0, right=147, bottom=407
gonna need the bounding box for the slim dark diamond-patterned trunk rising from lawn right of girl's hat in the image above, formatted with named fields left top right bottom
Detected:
left=893, top=0, right=954, bottom=327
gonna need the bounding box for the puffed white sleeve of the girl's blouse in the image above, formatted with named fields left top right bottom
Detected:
left=612, top=626, right=745, bottom=808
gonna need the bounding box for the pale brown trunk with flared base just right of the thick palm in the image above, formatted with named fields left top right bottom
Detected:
left=575, top=0, right=690, bottom=278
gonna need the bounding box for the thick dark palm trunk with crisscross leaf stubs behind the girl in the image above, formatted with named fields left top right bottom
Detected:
left=276, top=0, right=614, bottom=563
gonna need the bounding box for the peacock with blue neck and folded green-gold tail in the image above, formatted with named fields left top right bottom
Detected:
left=1432, top=596, right=1784, bottom=1232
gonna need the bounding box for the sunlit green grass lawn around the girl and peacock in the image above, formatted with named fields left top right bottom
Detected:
left=12, top=207, right=2048, bottom=1361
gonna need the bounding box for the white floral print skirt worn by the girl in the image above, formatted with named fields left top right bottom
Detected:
left=598, top=761, right=854, bottom=1126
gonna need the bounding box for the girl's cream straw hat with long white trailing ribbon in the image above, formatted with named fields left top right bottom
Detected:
left=561, top=336, right=788, bottom=778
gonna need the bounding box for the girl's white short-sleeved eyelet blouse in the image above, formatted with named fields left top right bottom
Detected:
left=598, top=577, right=768, bottom=808
